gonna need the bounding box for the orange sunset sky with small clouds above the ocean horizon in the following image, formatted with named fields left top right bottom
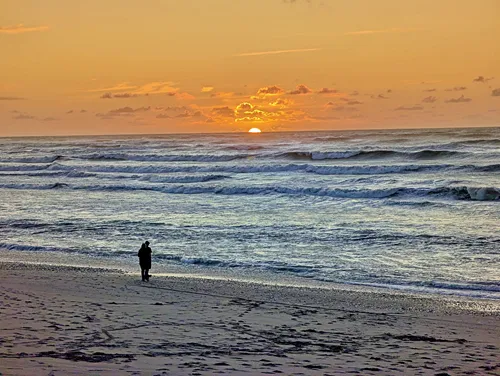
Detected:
left=0, top=0, right=500, bottom=137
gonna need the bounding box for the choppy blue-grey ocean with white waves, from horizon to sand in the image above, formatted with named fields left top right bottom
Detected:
left=0, top=128, right=500, bottom=299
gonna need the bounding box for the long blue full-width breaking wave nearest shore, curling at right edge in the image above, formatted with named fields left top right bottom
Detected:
left=0, top=182, right=500, bottom=201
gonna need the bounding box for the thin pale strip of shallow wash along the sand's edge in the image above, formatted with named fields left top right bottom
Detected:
left=0, top=248, right=500, bottom=304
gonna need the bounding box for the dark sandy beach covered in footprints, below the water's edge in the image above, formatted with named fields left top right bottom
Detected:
left=0, top=262, right=500, bottom=376
